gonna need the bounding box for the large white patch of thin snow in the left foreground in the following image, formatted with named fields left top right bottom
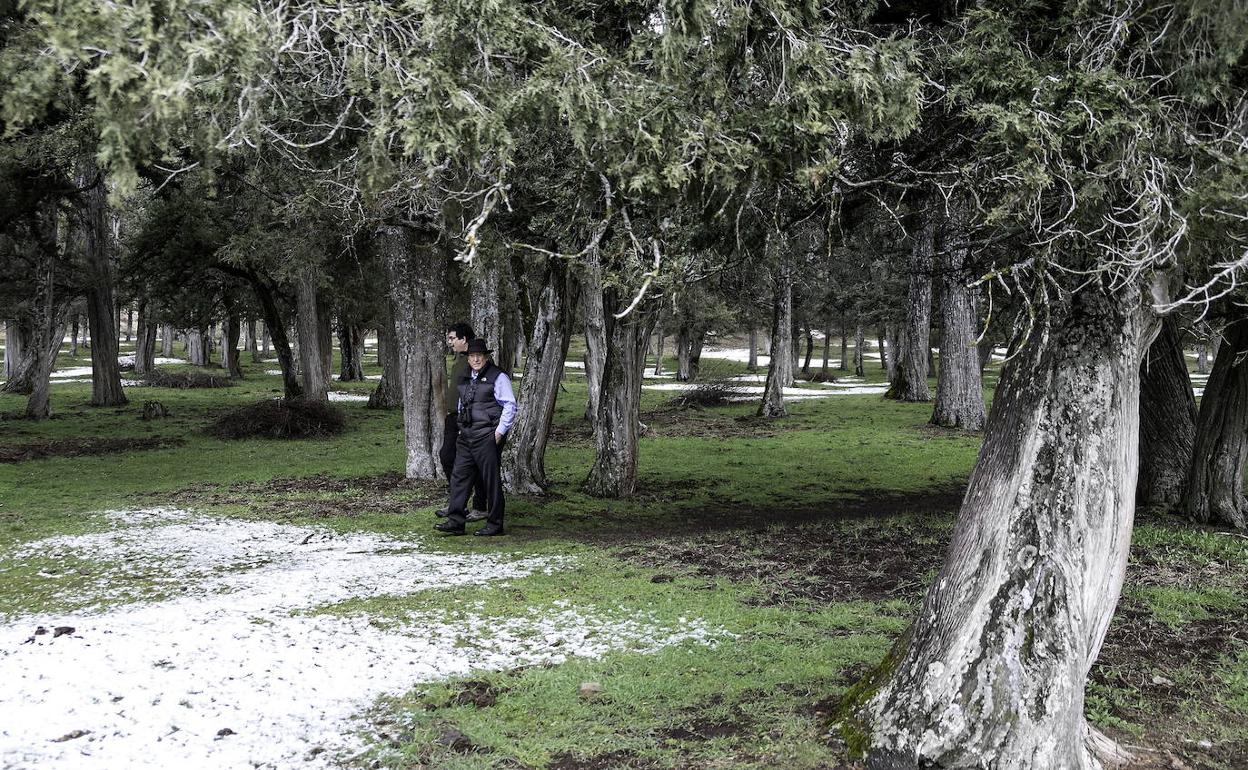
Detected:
left=0, top=509, right=725, bottom=770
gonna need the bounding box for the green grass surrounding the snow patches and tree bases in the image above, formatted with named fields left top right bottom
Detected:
left=0, top=341, right=1248, bottom=769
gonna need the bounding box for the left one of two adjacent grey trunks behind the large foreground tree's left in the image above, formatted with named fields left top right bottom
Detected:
left=885, top=215, right=936, bottom=401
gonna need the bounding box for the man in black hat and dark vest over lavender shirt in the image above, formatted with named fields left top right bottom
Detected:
left=433, top=339, right=517, bottom=537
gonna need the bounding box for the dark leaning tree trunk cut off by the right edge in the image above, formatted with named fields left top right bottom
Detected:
left=1179, top=313, right=1248, bottom=529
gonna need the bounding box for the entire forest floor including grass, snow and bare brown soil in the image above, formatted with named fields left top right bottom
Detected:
left=0, top=336, right=1248, bottom=770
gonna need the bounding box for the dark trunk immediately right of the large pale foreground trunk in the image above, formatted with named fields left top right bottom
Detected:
left=1136, top=316, right=1196, bottom=508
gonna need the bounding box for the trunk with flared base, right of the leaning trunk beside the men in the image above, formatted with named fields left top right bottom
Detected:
left=582, top=288, right=654, bottom=498
